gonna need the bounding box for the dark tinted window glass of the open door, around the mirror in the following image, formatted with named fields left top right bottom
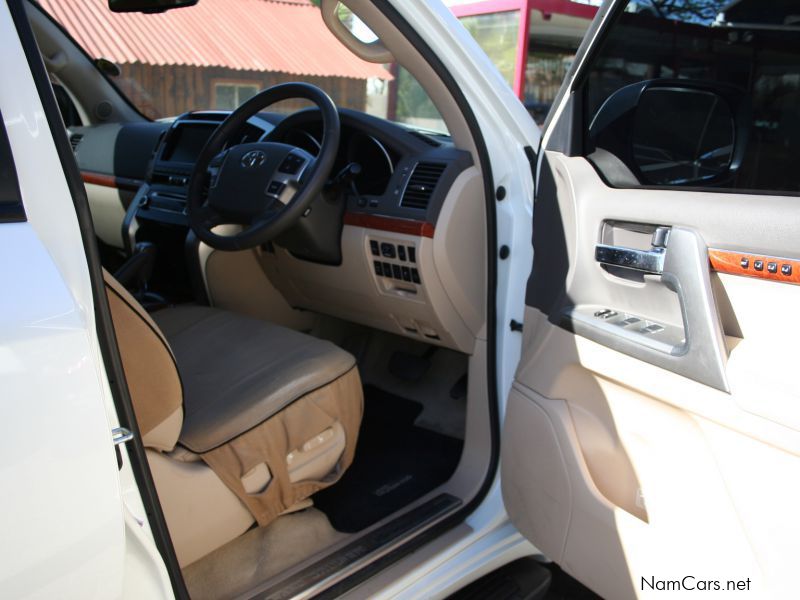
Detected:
left=584, top=0, right=800, bottom=193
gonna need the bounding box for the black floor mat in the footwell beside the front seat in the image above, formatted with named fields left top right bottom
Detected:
left=314, top=386, right=463, bottom=533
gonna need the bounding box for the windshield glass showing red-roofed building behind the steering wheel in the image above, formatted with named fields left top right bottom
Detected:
left=40, top=0, right=447, bottom=133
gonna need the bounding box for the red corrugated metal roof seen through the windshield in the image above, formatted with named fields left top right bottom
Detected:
left=39, top=0, right=391, bottom=79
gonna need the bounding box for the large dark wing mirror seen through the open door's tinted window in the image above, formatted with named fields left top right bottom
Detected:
left=589, top=79, right=750, bottom=185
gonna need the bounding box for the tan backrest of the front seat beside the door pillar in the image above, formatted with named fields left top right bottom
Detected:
left=103, top=270, right=183, bottom=452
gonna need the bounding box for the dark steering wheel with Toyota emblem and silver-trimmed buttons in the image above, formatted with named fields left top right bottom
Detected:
left=187, top=83, right=340, bottom=250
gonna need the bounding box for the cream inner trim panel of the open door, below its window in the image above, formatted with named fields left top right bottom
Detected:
left=502, top=151, right=800, bottom=599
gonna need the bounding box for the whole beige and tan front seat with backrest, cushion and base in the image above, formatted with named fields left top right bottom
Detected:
left=105, top=273, right=363, bottom=565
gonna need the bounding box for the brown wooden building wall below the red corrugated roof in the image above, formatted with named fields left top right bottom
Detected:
left=115, top=63, right=367, bottom=119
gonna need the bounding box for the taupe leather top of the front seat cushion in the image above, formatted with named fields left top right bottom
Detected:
left=153, top=306, right=355, bottom=453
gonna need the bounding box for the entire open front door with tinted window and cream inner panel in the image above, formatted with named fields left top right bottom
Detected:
left=502, top=0, right=800, bottom=600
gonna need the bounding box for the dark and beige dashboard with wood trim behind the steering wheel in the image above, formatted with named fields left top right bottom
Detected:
left=71, top=109, right=485, bottom=352
